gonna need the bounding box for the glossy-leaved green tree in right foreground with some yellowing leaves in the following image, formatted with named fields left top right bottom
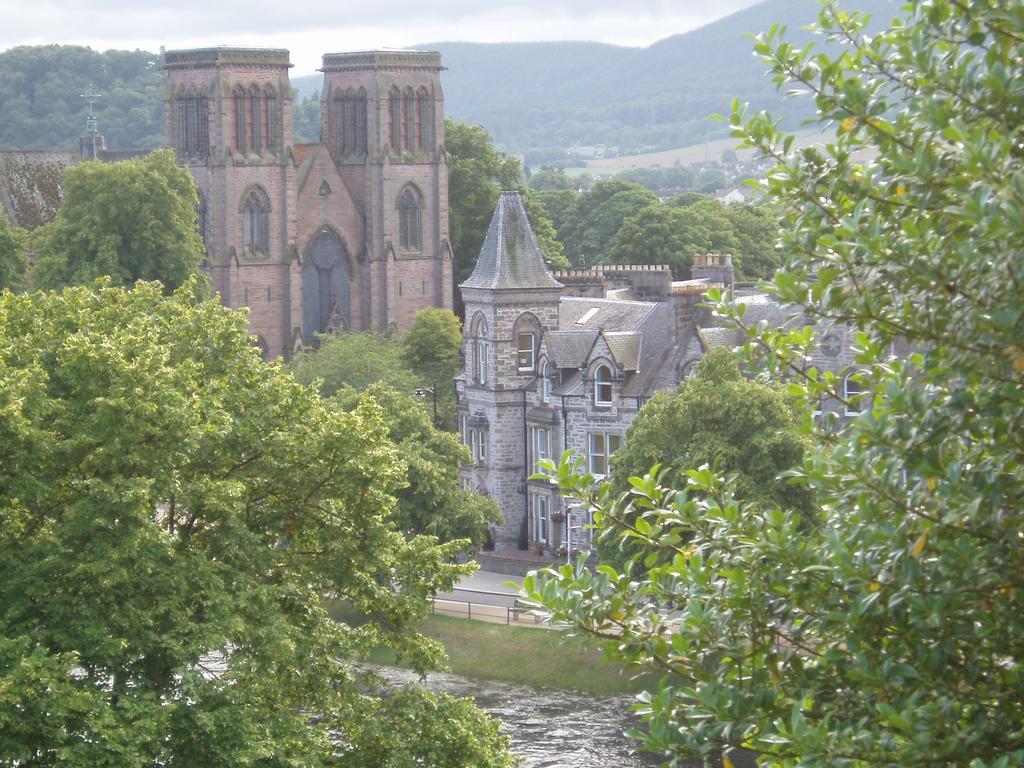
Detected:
left=526, top=0, right=1024, bottom=768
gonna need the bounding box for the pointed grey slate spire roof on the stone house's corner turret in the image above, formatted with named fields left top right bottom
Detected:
left=459, top=191, right=562, bottom=290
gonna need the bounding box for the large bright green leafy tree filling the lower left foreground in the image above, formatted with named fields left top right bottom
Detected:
left=0, top=279, right=511, bottom=768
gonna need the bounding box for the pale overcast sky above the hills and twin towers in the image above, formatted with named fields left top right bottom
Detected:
left=0, top=0, right=757, bottom=76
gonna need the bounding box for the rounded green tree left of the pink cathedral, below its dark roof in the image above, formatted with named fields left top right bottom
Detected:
left=32, top=150, right=205, bottom=292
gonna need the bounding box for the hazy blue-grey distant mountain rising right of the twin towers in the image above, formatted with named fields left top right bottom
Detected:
left=295, top=0, right=899, bottom=154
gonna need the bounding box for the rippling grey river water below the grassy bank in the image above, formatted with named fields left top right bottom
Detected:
left=379, top=667, right=660, bottom=768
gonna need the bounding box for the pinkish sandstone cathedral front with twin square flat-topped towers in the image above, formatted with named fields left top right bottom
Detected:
left=164, top=48, right=452, bottom=356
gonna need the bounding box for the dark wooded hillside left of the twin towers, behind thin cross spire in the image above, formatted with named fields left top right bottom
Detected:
left=0, top=45, right=166, bottom=150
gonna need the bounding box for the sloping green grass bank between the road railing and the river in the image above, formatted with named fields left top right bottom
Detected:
left=329, top=605, right=654, bottom=695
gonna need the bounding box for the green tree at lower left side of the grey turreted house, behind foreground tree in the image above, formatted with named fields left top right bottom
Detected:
left=336, top=382, right=501, bottom=550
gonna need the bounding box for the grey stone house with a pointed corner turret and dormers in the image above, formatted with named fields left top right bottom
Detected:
left=456, top=193, right=872, bottom=554
